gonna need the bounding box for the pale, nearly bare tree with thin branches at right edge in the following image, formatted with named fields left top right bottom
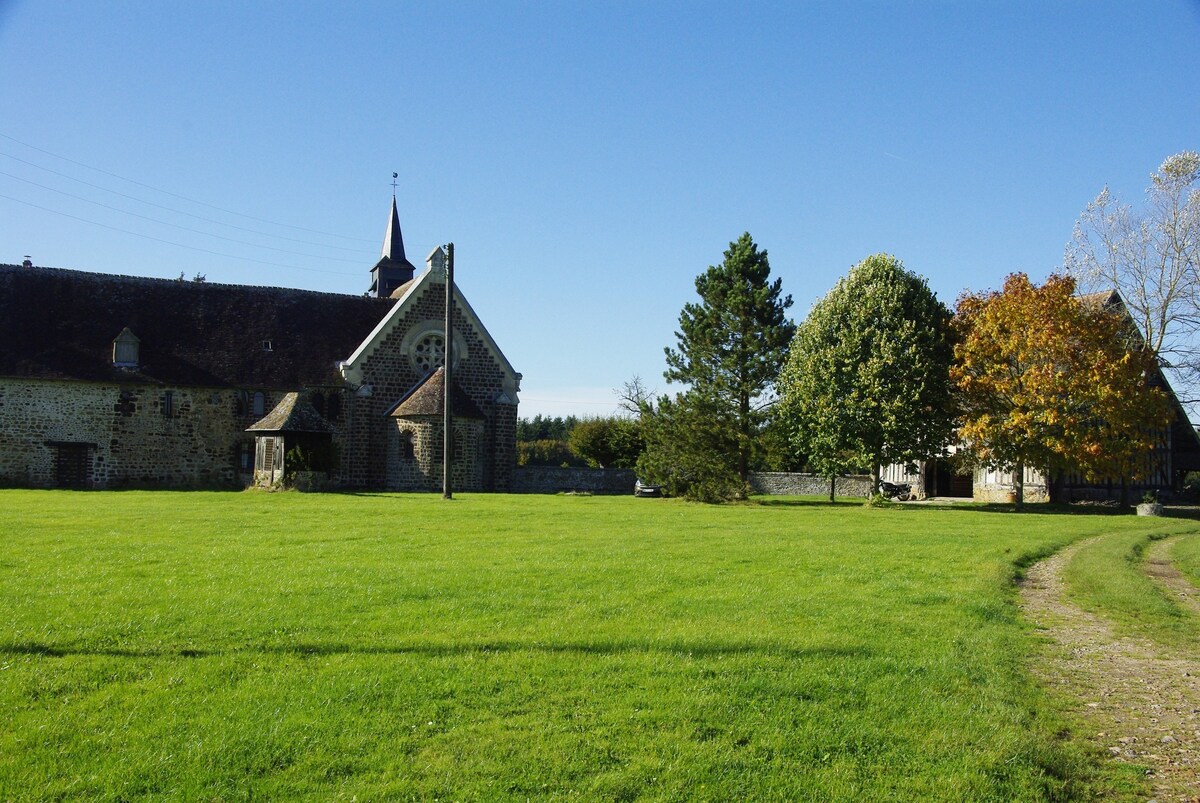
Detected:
left=1063, top=151, right=1200, bottom=386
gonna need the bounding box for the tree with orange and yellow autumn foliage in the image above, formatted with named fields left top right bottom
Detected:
left=950, top=274, right=1172, bottom=504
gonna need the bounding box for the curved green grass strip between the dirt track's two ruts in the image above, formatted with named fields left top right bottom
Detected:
left=1063, top=522, right=1200, bottom=651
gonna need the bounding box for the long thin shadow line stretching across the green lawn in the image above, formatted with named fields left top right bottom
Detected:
left=0, top=641, right=874, bottom=660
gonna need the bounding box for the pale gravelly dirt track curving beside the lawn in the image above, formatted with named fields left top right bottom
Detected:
left=1021, top=541, right=1200, bottom=803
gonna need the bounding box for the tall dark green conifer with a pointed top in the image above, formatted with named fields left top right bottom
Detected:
left=648, top=233, right=796, bottom=486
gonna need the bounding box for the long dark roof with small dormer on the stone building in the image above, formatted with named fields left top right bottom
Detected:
left=0, top=265, right=395, bottom=388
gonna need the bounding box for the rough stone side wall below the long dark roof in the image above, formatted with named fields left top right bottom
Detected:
left=0, top=379, right=281, bottom=489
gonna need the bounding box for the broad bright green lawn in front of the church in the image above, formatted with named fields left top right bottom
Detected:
left=0, top=491, right=1196, bottom=801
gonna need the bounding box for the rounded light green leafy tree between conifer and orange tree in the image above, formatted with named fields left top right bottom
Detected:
left=779, top=254, right=954, bottom=487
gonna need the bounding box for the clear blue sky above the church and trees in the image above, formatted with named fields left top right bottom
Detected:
left=0, top=0, right=1200, bottom=417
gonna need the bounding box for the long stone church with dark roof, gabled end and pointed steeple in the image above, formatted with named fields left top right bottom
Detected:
left=0, top=198, right=521, bottom=491
